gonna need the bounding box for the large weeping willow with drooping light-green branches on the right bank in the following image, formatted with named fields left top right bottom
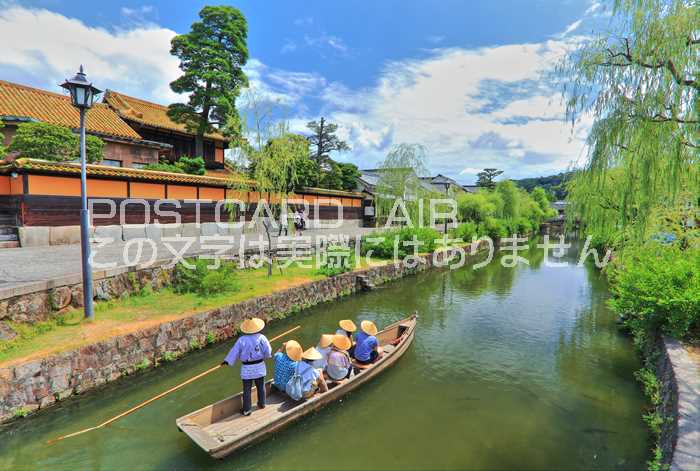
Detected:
left=560, top=0, right=700, bottom=242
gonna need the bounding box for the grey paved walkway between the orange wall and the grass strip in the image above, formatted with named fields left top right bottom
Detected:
left=0, top=227, right=374, bottom=299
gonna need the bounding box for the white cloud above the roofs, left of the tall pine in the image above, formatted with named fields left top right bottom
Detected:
left=0, top=6, right=179, bottom=103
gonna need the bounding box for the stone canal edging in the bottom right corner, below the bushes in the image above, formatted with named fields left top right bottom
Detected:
left=656, top=338, right=700, bottom=471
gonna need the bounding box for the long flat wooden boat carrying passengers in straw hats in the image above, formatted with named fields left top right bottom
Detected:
left=176, top=314, right=418, bottom=458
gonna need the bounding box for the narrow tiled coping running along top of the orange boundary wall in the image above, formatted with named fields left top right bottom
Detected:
left=0, top=158, right=254, bottom=187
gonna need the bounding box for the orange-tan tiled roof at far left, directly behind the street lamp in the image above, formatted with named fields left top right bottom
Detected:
left=0, top=80, right=141, bottom=140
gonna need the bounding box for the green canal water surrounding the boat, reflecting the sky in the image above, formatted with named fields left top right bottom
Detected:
left=0, top=242, right=649, bottom=470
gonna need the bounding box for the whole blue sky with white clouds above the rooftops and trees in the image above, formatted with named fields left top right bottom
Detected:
left=0, top=0, right=606, bottom=183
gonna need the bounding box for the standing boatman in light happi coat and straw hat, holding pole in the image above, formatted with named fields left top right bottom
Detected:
left=221, top=317, right=272, bottom=416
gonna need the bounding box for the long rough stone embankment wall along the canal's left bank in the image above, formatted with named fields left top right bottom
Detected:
left=0, top=247, right=482, bottom=423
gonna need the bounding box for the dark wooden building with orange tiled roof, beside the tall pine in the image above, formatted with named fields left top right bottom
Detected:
left=104, top=90, right=229, bottom=169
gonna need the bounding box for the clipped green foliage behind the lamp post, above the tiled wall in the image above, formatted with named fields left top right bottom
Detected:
left=8, top=122, right=104, bottom=163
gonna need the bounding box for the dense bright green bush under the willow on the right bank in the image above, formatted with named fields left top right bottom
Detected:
left=610, top=242, right=700, bottom=344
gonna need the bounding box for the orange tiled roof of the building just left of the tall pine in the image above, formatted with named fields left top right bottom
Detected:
left=104, top=90, right=228, bottom=141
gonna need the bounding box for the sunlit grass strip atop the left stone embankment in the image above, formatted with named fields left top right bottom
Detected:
left=0, top=257, right=388, bottom=367
